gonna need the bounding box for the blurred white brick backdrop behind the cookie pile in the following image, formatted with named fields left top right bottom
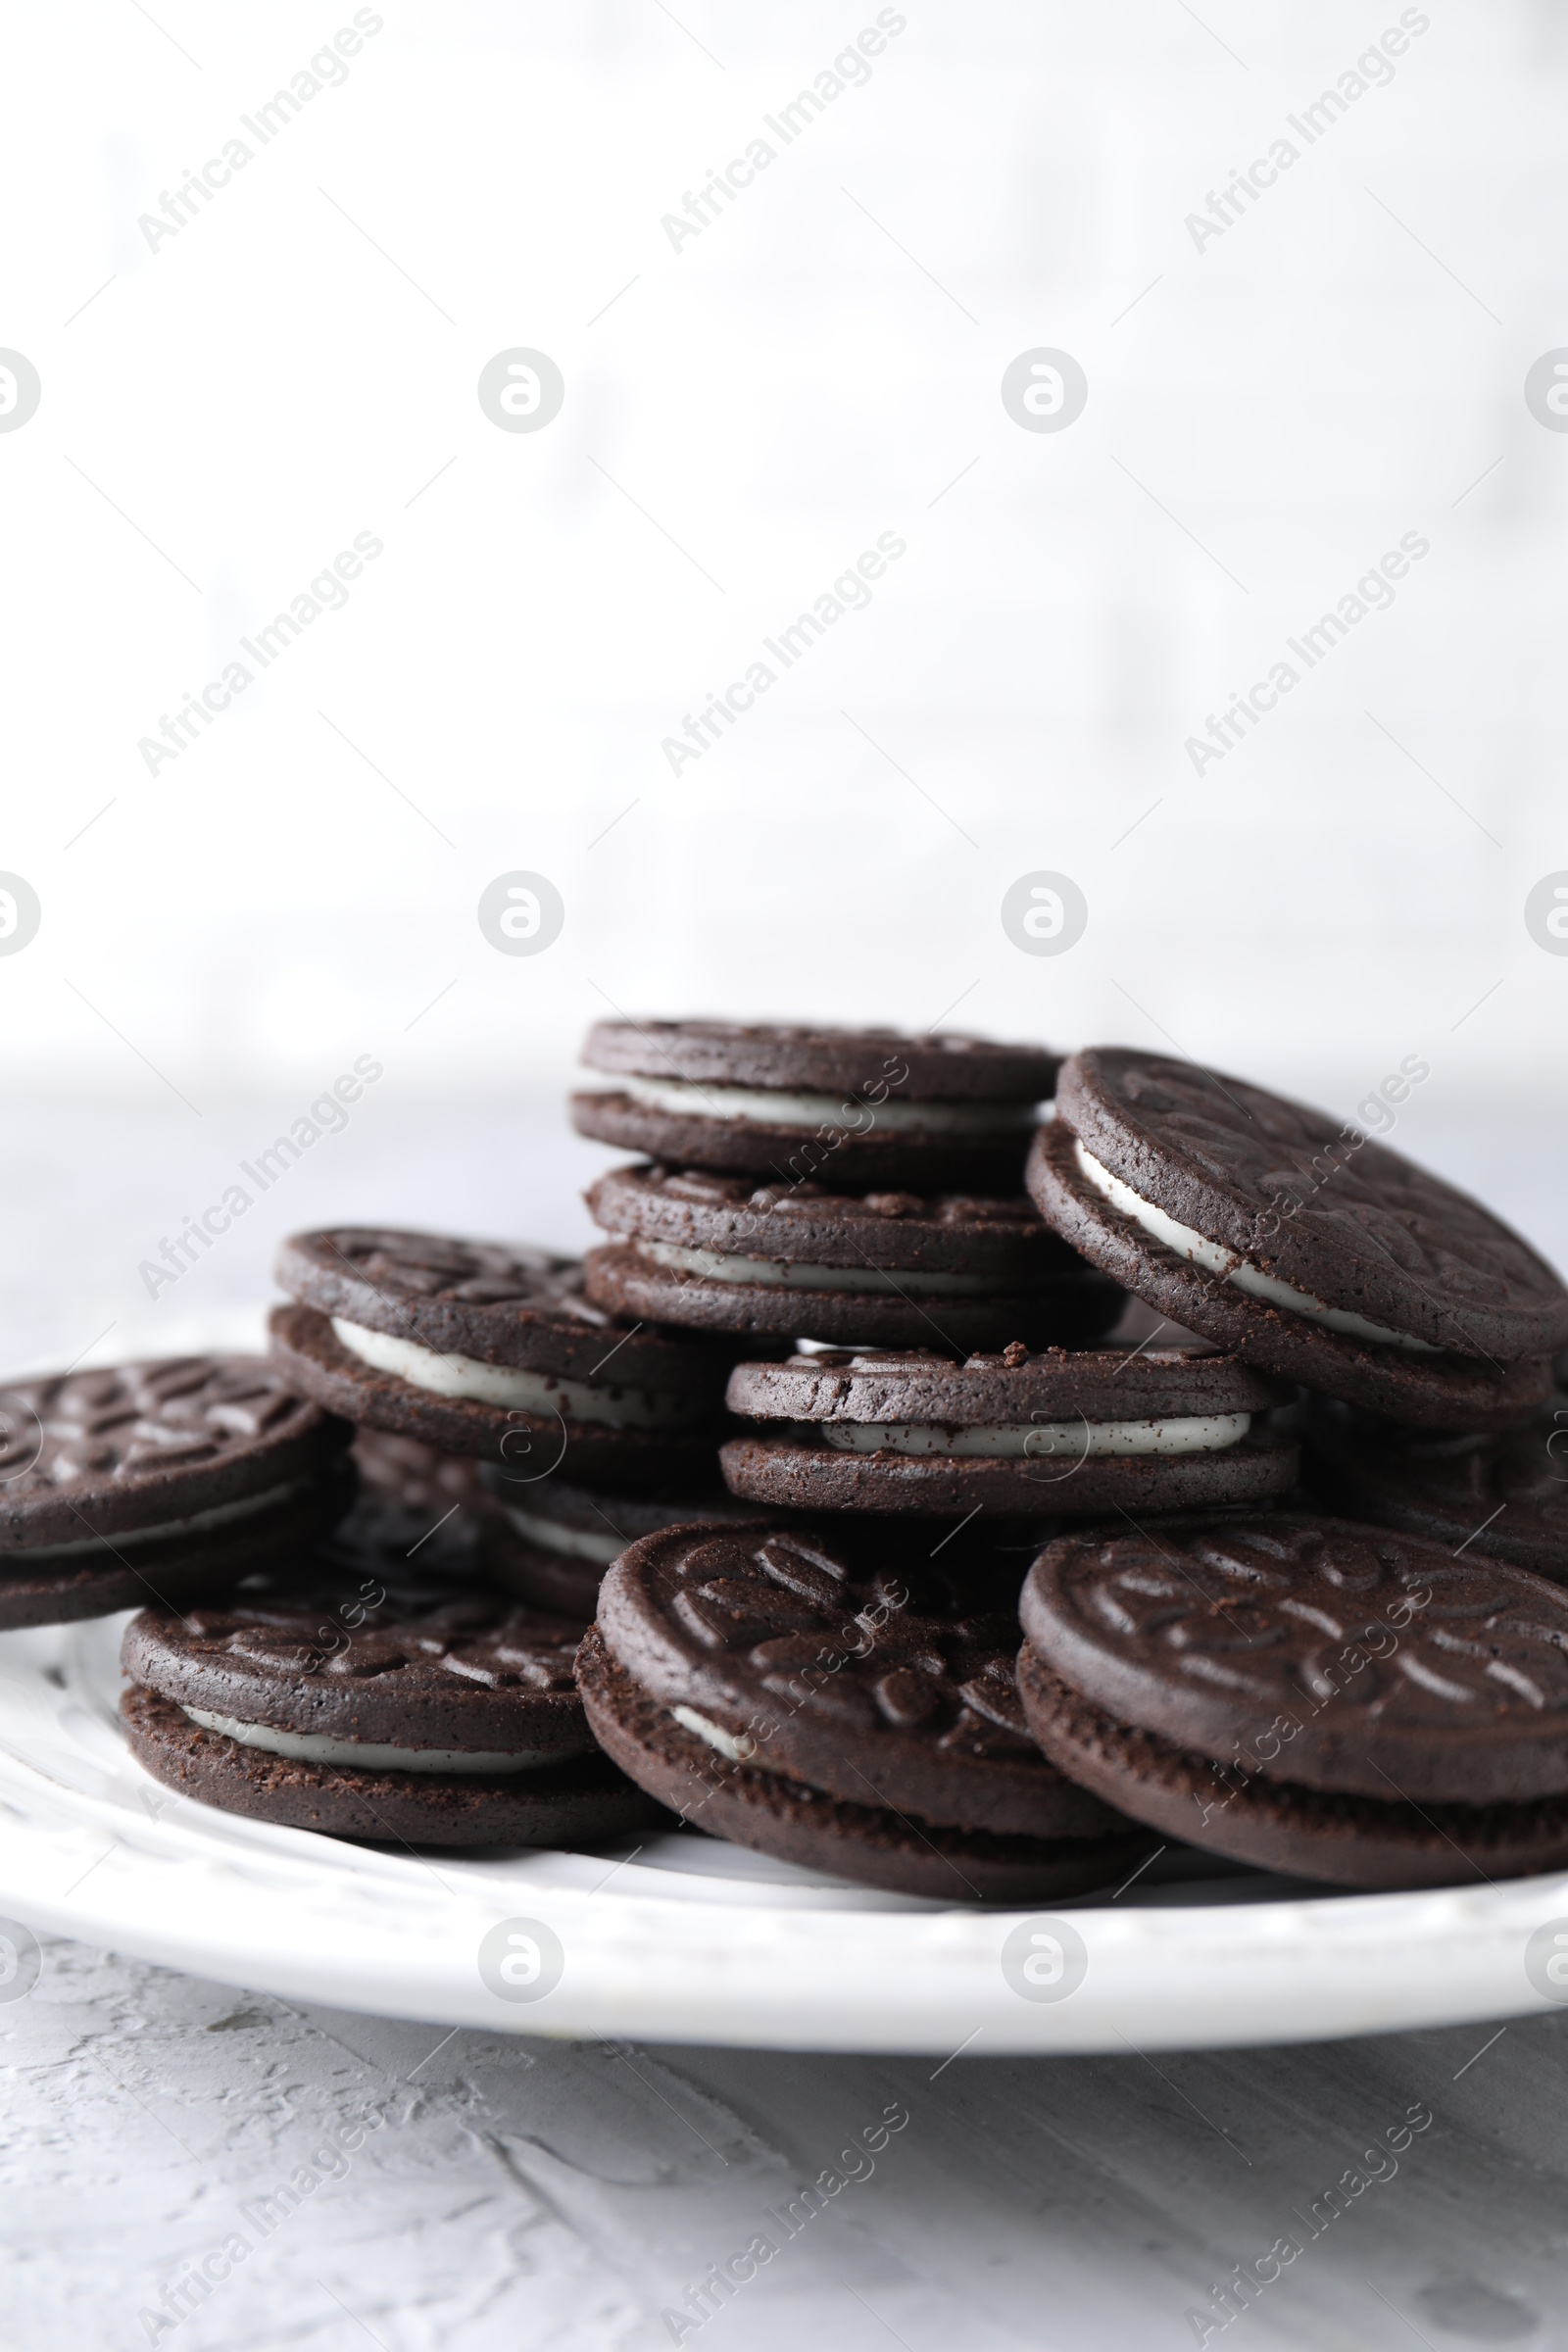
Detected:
left=0, top=0, right=1568, bottom=1369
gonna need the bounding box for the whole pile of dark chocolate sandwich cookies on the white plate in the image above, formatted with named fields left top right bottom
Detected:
left=55, top=1021, right=1568, bottom=1903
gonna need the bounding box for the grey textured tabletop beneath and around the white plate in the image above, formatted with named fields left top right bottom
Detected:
left=0, top=1101, right=1568, bottom=2352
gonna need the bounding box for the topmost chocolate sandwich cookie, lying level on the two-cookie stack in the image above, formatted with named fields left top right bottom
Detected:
left=571, top=1021, right=1060, bottom=1193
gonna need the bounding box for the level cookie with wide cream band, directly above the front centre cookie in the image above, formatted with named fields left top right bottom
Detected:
left=719, top=1346, right=1298, bottom=1519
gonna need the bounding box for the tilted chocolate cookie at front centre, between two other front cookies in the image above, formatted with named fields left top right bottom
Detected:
left=578, top=1527, right=1148, bottom=1903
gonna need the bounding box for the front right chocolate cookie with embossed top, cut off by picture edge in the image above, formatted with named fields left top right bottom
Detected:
left=1018, top=1512, right=1568, bottom=1886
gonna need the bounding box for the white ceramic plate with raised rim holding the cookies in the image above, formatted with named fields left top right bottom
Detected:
left=0, top=1618, right=1568, bottom=2058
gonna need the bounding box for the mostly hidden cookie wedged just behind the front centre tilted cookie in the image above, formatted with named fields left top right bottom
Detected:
left=482, top=1468, right=783, bottom=1625
